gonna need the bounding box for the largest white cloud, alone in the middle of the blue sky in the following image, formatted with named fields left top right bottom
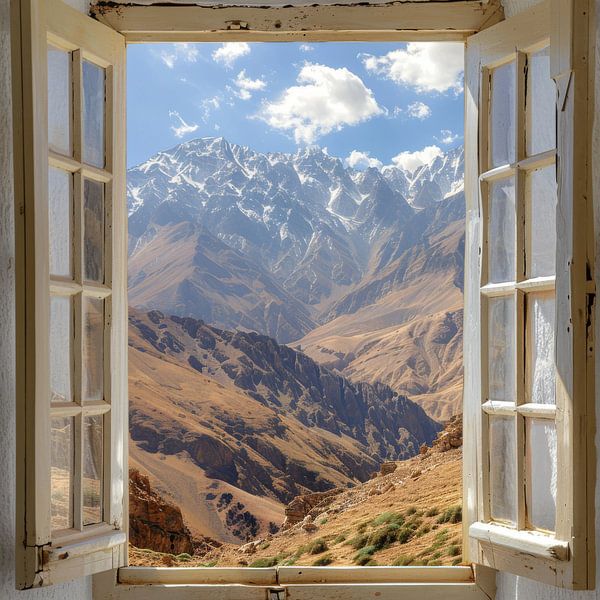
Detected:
left=257, top=63, right=384, bottom=144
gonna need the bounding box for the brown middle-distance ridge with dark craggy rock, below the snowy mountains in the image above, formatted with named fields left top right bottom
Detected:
left=129, top=310, right=440, bottom=542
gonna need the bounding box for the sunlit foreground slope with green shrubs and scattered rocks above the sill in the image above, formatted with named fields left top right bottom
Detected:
left=130, top=417, right=462, bottom=567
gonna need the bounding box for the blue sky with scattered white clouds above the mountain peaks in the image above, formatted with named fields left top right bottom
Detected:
left=127, top=42, right=464, bottom=170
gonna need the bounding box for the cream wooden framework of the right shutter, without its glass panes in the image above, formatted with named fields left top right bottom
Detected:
left=463, top=0, right=596, bottom=589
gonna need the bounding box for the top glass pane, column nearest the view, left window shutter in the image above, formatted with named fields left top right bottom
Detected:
left=83, top=60, right=104, bottom=168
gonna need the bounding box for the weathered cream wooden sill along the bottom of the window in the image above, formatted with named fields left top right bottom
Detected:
left=94, top=567, right=491, bottom=600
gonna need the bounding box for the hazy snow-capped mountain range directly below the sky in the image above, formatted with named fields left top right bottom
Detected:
left=128, top=138, right=463, bottom=342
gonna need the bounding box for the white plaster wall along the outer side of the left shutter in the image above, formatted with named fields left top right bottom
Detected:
left=0, top=0, right=92, bottom=600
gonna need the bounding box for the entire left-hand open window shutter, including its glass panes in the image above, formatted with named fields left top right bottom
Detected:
left=11, top=0, right=127, bottom=589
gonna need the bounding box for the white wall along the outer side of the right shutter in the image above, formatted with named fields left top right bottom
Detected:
left=496, top=0, right=600, bottom=600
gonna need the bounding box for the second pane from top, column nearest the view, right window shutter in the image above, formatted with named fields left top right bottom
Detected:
left=488, top=177, right=516, bottom=283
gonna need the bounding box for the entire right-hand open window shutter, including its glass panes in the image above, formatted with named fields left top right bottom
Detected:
left=464, top=0, right=595, bottom=589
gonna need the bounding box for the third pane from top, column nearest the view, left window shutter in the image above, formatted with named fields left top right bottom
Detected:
left=83, top=297, right=104, bottom=400
